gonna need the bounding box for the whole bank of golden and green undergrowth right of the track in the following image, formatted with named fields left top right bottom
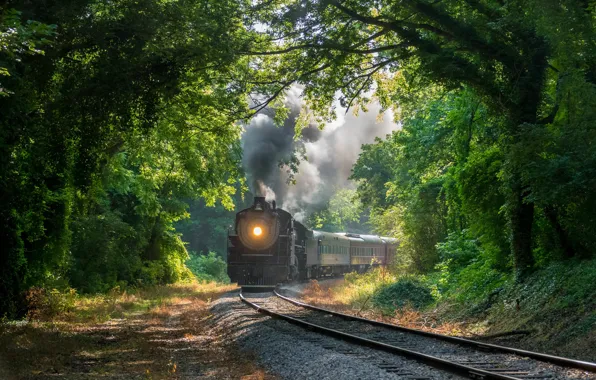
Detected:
left=304, top=259, right=596, bottom=361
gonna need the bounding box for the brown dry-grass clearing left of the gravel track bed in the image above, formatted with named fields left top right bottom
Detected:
left=0, top=283, right=272, bottom=379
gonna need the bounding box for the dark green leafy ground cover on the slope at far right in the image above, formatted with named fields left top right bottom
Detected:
left=452, top=259, right=596, bottom=360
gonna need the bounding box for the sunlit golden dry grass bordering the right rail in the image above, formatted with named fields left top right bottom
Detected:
left=301, top=279, right=473, bottom=336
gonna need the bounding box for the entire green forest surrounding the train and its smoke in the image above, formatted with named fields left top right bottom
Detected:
left=0, top=0, right=596, bottom=318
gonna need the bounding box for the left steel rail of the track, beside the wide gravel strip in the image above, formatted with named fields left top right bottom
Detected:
left=239, top=291, right=522, bottom=380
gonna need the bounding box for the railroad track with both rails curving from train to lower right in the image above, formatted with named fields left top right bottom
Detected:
left=240, top=291, right=596, bottom=380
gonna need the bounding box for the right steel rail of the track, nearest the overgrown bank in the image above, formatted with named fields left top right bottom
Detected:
left=274, top=290, right=596, bottom=372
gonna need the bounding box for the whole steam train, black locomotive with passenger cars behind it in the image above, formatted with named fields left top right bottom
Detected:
left=228, top=197, right=397, bottom=287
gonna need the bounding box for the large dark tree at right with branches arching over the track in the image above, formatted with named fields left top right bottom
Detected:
left=250, top=0, right=594, bottom=274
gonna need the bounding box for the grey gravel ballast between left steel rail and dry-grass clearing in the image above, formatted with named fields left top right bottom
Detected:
left=211, top=292, right=461, bottom=380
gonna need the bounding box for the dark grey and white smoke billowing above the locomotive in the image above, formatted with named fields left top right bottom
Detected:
left=242, top=89, right=398, bottom=219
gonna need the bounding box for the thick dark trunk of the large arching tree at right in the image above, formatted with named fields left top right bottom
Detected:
left=509, top=177, right=534, bottom=280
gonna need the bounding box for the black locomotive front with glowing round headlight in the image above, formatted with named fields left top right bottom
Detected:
left=228, top=197, right=306, bottom=286
